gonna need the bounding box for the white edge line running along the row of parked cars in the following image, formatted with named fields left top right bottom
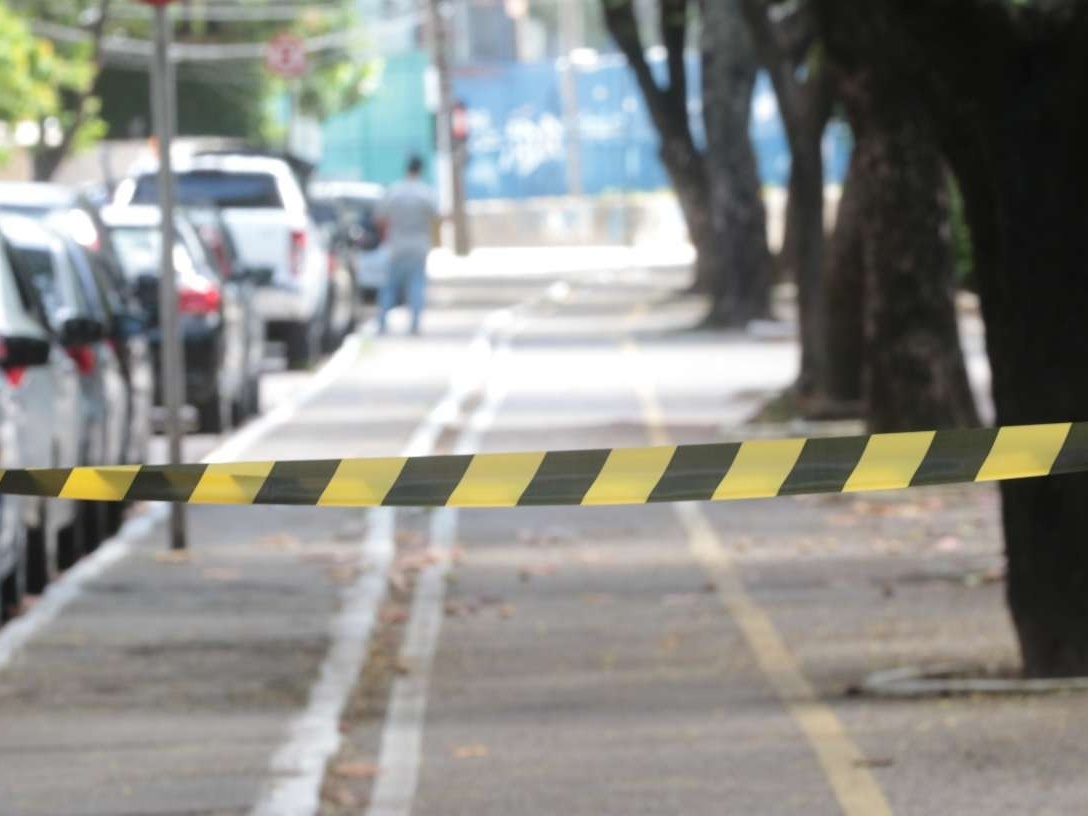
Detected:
left=0, top=321, right=374, bottom=671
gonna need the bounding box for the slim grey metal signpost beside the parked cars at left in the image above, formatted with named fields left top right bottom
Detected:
left=151, top=5, right=185, bottom=549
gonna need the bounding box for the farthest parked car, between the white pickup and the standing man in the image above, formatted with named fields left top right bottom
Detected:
left=309, top=181, right=388, bottom=299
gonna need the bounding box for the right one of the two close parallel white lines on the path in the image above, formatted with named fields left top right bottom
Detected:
left=367, top=323, right=520, bottom=816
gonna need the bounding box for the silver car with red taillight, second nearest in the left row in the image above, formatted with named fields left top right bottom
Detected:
left=0, top=214, right=128, bottom=569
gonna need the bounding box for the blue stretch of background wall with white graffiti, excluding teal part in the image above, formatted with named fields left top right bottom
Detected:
left=454, top=59, right=850, bottom=199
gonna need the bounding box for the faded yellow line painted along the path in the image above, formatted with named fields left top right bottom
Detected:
left=623, top=337, right=891, bottom=816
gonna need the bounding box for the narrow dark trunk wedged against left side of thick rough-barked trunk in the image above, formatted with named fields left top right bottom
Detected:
left=824, top=149, right=866, bottom=406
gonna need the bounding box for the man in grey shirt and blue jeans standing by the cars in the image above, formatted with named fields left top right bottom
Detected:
left=378, top=156, right=438, bottom=334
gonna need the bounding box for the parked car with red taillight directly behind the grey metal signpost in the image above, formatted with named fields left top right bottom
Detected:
left=102, top=206, right=263, bottom=433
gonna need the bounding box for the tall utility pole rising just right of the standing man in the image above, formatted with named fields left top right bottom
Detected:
left=428, top=0, right=470, bottom=256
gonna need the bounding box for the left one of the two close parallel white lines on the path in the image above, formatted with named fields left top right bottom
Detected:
left=251, top=309, right=526, bottom=816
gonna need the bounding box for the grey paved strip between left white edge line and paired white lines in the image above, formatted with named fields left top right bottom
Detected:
left=0, top=282, right=548, bottom=816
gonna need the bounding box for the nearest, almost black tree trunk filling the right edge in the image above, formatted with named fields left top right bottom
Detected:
left=819, top=0, right=1088, bottom=676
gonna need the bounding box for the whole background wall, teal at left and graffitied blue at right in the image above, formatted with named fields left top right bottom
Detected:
left=320, top=51, right=850, bottom=199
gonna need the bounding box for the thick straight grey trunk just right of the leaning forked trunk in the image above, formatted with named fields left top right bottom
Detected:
left=703, top=0, right=770, bottom=326
